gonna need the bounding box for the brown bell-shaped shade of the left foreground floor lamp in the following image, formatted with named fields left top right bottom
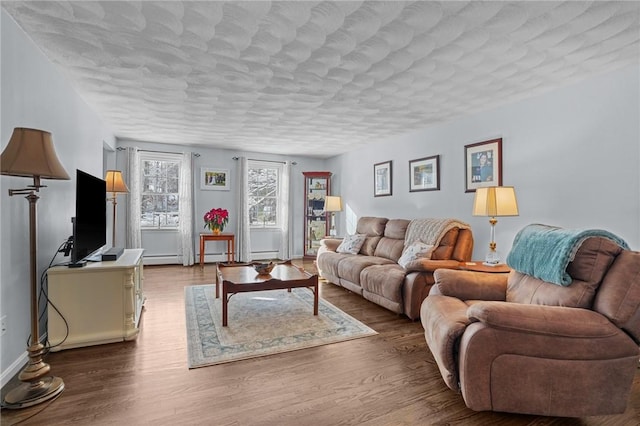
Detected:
left=0, top=127, right=69, bottom=180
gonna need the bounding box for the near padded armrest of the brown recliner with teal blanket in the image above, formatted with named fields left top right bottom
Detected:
left=467, top=302, right=620, bottom=339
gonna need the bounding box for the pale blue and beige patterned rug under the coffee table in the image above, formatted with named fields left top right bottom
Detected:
left=184, top=285, right=377, bottom=368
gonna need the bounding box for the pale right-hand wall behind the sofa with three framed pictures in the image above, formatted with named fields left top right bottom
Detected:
left=327, top=66, right=640, bottom=259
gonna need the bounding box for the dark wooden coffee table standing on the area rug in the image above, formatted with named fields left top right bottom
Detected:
left=216, top=261, right=319, bottom=327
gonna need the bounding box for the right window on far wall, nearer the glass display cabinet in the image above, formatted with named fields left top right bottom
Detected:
left=248, top=161, right=282, bottom=228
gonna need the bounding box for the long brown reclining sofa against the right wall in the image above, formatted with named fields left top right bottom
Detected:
left=316, top=217, right=473, bottom=320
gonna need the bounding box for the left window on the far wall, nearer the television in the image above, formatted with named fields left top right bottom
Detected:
left=140, top=153, right=180, bottom=229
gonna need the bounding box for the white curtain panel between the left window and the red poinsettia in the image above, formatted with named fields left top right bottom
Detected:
left=178, top=152, right=194, bottom=266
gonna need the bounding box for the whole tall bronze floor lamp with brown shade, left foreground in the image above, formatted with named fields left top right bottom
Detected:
left=0, top=127, right=69, bottom=409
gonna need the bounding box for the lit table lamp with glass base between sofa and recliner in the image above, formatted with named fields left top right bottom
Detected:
left=473, top=186, right=518, bottom=266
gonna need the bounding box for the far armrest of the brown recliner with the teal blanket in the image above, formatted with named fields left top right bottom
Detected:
left=429, top=269, right=508, bottom=301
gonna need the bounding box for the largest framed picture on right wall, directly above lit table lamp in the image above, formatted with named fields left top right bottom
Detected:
left=464, top=138, right=502, bottom=192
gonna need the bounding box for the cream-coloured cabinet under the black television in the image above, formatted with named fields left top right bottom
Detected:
left=47, top=249, right=145, bottom=351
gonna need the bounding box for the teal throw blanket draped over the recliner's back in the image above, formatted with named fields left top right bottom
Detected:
left=507, top=224, right=629, bottom=286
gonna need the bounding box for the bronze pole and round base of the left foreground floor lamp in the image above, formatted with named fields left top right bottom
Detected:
left=4, top=185, right=64, bottom=408
